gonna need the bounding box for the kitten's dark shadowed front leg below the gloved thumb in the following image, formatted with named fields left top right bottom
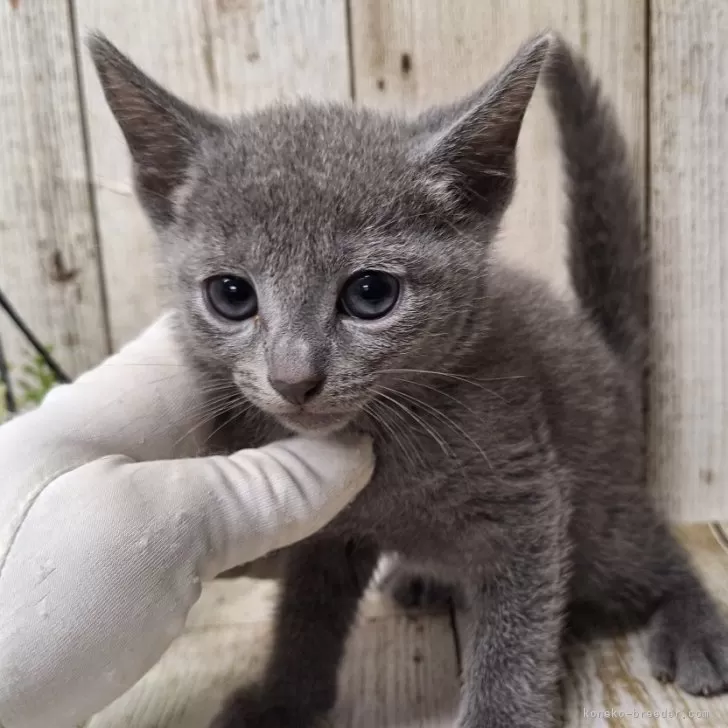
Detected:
left=213, top=537, right=379, bottom=728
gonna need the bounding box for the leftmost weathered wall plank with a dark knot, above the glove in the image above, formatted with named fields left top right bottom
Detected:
left=0, top=2, right=107, bottom=384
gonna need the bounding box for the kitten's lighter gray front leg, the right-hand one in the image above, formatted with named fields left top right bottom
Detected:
left=457, top=516, right=567, bottom=728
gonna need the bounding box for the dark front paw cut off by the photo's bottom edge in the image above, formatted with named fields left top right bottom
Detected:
left=210, top=690, right=316, bottom=728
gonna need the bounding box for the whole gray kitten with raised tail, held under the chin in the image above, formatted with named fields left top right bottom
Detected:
left=91, top=29, right=728, bottom=728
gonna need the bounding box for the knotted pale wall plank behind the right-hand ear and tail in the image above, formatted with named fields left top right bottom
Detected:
left=352, top=0, right=646, bottom=302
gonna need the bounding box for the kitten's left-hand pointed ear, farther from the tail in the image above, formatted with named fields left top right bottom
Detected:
left=88, top=33, right=217, bottom=226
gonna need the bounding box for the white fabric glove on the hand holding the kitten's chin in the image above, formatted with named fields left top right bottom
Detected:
left=0, top=315, right=373, bottom=728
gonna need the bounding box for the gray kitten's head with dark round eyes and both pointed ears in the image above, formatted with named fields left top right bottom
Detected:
left=90, top=36, right=549, bottom=433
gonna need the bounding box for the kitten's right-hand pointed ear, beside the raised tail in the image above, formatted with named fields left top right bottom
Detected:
left=417, top=33, right=552, bottom=213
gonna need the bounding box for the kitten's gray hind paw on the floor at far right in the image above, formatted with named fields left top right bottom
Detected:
left=648, top=595, right=728, bottom=695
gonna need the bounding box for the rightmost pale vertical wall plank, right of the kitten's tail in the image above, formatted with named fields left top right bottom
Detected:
left=650, top=0, right=728, bottom=520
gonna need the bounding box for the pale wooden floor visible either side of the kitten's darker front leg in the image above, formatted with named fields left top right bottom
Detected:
left=87, top=578, right=459, bottom=728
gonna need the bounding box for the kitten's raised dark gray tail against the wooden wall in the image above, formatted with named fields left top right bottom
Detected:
left=544, top=36, right=647, bottom=375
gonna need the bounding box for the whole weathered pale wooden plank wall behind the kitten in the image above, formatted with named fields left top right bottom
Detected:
left=0, top=0, right=728, bottom=520
